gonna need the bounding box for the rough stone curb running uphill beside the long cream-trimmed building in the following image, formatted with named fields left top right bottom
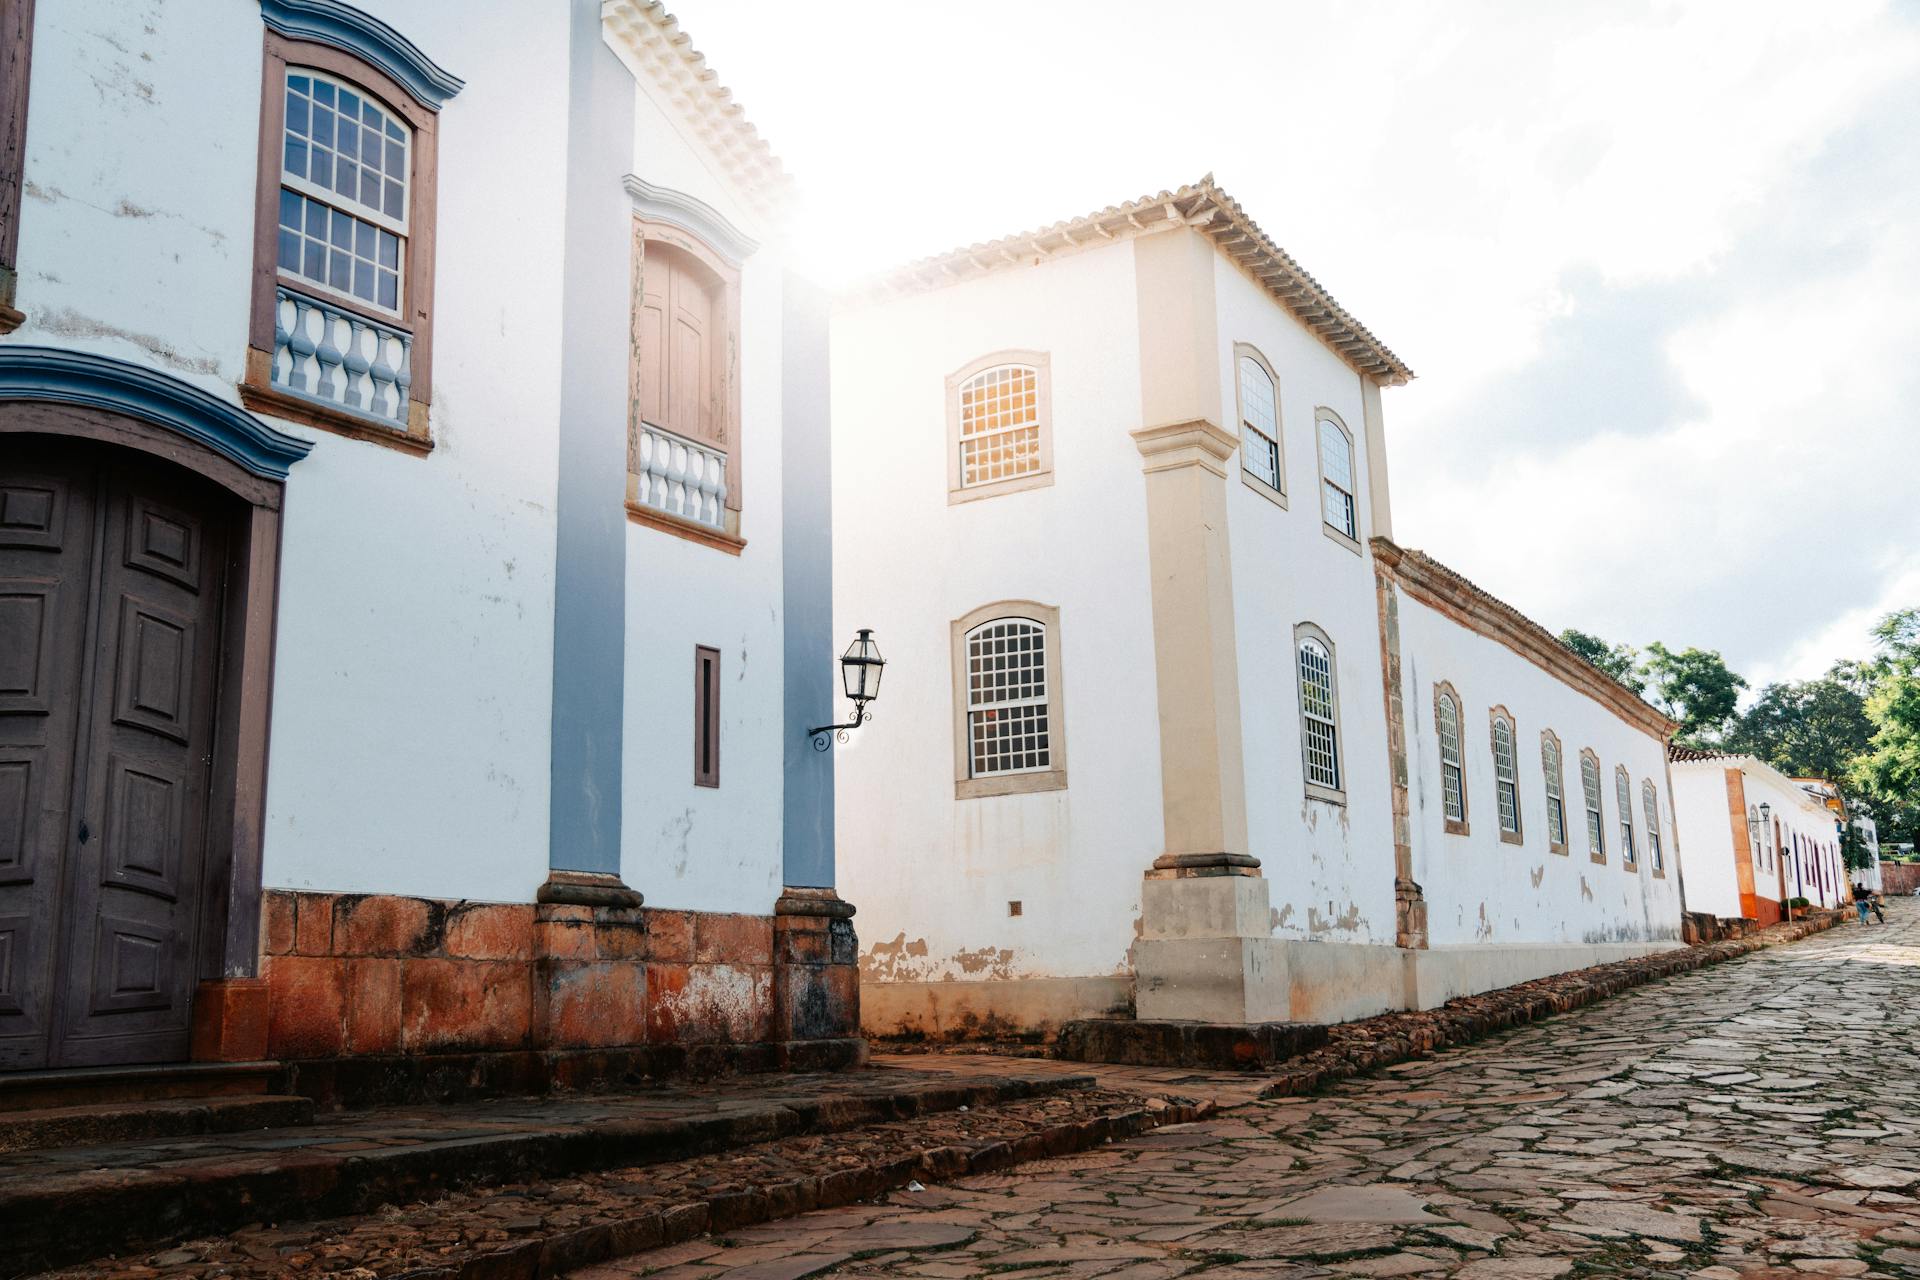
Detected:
left=1260, top=913, right=1839, bottom=1098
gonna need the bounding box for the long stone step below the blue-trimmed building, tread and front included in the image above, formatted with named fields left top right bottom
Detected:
left=0, top=1069, right=1092, bottom=1276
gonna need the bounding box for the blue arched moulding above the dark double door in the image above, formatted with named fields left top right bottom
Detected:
left=0, top=345, right=313, bottom=480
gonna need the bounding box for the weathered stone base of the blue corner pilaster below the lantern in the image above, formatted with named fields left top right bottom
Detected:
left=772, top=889, right=860, bottom=1044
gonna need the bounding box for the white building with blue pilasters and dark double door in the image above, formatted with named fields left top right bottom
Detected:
left=0, top=0, right=852, bottom=1090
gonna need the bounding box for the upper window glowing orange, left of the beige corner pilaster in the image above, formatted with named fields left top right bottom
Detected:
left=947, top=351, right=1054, bottom=503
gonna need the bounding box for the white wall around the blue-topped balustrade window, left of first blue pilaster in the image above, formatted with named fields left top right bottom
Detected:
left=10, top=0, right=568, bottom=900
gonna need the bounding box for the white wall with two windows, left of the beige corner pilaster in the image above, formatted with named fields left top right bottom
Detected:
left=833, top=244, right=1162, bottom=983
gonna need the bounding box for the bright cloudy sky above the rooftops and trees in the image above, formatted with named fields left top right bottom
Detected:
left=672, top=0, right=1920, bottom=685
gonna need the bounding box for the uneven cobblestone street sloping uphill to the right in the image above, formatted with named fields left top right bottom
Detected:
left=576, top=900, right=1920, bottom=1280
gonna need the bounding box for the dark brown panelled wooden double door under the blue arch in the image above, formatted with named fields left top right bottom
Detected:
left=0, top=434, right=234, bottom=1069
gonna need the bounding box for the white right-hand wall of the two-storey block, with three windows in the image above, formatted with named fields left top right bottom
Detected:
left=1213, top=255, right=1394, bottom=946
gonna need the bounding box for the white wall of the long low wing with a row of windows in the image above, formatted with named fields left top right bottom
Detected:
left=1400, top=591, right=1680, bottom=948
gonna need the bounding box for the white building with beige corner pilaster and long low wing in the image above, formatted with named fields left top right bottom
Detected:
left=833, top=178, right=1680, bottom=1034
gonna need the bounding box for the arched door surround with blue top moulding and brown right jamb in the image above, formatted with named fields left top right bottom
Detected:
left=0, top=345, right=313, bottom=1028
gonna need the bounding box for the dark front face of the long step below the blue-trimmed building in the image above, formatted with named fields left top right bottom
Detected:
left=0, top=1075, right=1092, bottom=1276
